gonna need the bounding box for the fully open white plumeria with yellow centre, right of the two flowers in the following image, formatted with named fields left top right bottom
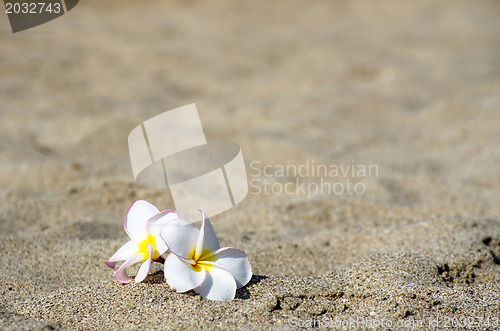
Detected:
left=160, top=209, right=252, bottom=301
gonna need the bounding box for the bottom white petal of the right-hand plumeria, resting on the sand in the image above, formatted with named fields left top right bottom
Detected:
left=194, top=264, right=236, bottom=301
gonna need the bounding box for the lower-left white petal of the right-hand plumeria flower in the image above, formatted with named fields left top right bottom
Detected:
left=164, top=254, right=207, bottom=293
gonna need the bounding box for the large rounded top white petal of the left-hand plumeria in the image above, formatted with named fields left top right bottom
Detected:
left=123, top=200, right=160, bottom=242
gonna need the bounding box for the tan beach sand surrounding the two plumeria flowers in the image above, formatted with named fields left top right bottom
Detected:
left=0, top=0, right=500, bottom=329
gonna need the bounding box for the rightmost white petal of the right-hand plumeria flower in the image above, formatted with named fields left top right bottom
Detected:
left=214, top=247, right=252, bottom=288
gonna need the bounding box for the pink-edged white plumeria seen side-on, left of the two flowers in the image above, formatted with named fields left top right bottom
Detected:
left=105, top=200, right=179, bottom=284
